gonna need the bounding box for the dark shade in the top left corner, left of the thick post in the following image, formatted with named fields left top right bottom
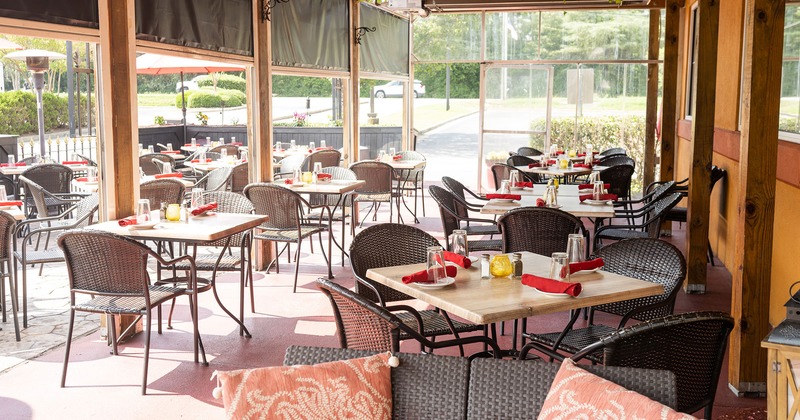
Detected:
left=0, top=0, right=100, bottom=29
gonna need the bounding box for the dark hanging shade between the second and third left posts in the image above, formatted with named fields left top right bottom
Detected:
left=271, top=0, right=350, bottom=71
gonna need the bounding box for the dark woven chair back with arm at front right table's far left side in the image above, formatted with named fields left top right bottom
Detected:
left=350, top=223, right=441, bottom=302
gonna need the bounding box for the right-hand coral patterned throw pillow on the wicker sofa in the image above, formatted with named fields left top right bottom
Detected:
left=539, top=359, right=694, bottom=420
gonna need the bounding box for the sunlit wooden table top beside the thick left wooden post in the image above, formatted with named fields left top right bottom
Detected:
left=87, top=211, right=269, bottom=242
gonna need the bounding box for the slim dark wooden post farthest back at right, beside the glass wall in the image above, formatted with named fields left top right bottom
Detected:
left=643, top=9, right=661, bottom=186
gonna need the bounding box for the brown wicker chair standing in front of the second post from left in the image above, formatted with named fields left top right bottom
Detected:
left=244, top=183, right=329, bottom=293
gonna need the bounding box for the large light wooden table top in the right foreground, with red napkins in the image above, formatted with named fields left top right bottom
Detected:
left=367, top=252, right=664, bottom=325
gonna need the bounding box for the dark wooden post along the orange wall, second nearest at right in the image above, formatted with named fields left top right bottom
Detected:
left=686, top=0, right=719, bottom=293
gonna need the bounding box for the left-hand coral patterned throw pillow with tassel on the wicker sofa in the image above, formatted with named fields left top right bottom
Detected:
left=216, top=353, right=392, bottom=419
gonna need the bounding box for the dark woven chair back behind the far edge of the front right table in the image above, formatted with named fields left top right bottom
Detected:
left=497, top=207, right=588, bottom=256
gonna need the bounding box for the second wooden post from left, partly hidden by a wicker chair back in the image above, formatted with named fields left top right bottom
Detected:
left=248, top=1, right=273, bottom=270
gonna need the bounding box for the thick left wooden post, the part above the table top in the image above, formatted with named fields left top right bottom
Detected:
left=98, top=0, right=139, bottom=220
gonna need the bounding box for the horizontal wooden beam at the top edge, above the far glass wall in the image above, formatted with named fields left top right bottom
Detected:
left=422, top=0, right=664, bottom=13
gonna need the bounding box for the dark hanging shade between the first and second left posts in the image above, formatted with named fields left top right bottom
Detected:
left=134, top=0, right=253, bottom=57
